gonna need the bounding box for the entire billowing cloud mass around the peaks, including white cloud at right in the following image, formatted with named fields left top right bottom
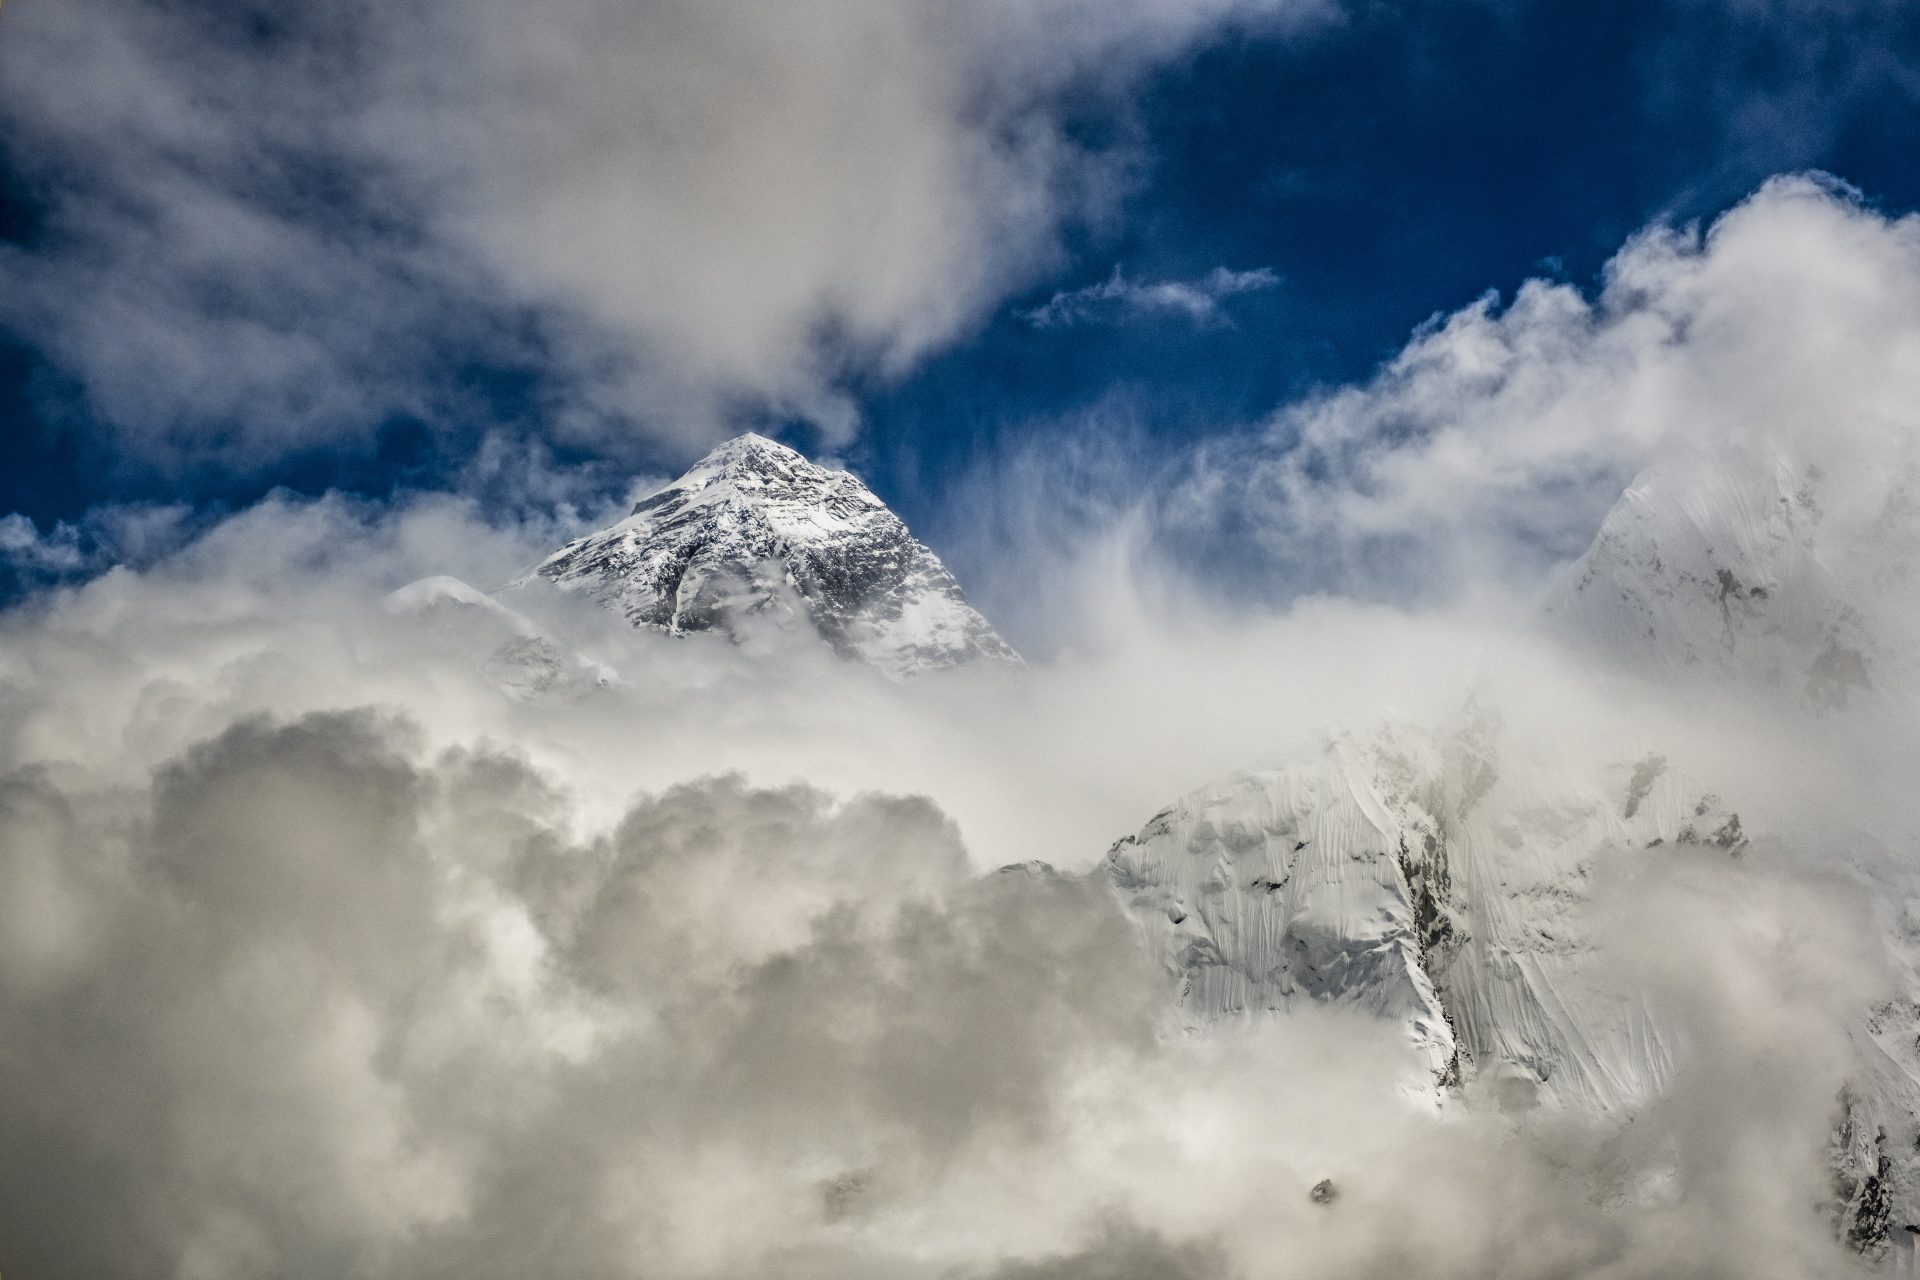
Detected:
left=0, top=182, right=1920, bottom=1280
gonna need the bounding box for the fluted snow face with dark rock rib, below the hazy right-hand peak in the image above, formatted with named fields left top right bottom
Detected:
left=1106, top=722, right=1747, bottom=1111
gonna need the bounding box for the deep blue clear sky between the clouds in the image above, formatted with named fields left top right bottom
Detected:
left=0, top=0, right=1920, bottom=564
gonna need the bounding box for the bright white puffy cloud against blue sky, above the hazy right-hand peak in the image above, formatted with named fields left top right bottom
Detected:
left=1144, top=177, right=1920, bottom=597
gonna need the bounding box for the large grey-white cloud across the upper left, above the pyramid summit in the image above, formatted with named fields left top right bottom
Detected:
left=0, top=0, right=1321, bottom=466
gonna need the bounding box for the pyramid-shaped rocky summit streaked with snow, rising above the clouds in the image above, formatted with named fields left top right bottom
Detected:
left=516, top=434, right=1020, bottom=677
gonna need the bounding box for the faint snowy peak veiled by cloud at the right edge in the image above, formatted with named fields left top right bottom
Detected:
left=1551, top=455, right=1920, bottom=708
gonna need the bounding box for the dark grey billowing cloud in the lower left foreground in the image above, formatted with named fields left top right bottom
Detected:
left=0, top=712, right=1154, bottom=1276
